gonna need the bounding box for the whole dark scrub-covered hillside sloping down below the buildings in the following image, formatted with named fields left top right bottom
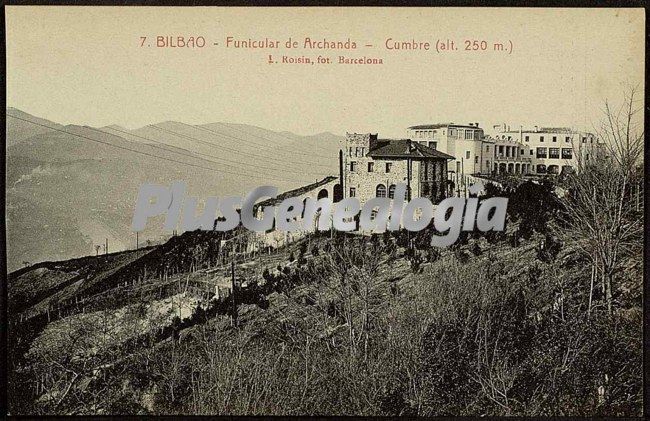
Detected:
left=9, top=90, right=643, bottom=416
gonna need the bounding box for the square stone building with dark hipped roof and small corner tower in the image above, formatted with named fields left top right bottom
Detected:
left=343, top=133, right=454, bottom=204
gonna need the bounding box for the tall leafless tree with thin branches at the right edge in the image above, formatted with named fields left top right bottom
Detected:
left=564, top=88, right=644, bottom=314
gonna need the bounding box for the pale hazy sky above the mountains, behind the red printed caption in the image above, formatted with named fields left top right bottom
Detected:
left=6, top=6, right=645, bottom=136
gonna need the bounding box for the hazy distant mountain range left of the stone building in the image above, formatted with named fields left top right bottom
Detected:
left=5, top=108, right=344, bottom=271
